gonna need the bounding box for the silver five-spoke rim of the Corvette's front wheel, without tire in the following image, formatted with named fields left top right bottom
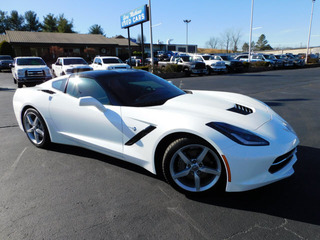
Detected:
left=170, top=144, right=222, bottom=192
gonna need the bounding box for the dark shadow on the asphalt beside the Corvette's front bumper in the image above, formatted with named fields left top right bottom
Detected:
left=187, top=146, right=320, bottom=225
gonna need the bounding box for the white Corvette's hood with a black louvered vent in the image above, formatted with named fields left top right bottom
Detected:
left=163, top=91, right=272, bottom=131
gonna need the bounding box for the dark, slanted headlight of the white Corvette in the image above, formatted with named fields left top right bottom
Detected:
left=206, top=122, right=269, bottom=146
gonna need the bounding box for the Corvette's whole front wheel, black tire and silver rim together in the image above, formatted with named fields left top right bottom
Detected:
left=162, top=138, right=226, bottom=194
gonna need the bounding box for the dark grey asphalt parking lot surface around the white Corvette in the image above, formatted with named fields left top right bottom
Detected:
left=0, top=68, right=320, bottom=240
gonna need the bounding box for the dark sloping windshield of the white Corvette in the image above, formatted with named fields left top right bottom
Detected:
left=97, top=72, right=185, bottom=107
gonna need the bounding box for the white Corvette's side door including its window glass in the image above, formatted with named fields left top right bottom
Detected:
left=49, top=76, right=123, bottom=158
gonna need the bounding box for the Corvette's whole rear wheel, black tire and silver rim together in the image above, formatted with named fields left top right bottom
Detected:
left=22, top=108, right=51, bottom=148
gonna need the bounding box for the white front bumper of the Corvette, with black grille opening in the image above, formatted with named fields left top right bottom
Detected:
left=223, top=119, right=299, bottom=192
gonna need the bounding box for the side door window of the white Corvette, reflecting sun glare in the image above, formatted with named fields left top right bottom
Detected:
left=67, top=76, right=110, bottom=104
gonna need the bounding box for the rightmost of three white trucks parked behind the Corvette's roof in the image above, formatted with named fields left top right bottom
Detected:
left=90, top=56, right=130, bottom=70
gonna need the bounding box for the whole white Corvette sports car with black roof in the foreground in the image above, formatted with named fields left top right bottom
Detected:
left=13, top=70, right=299, bottom=193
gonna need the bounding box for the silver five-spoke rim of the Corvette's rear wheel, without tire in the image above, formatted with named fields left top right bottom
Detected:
left=23, top=111, right=45, bottom=145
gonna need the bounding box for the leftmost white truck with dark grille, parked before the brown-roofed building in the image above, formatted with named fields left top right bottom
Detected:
left=11, top=57, right=52, bottom=88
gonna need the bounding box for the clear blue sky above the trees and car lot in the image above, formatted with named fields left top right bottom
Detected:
left=0, top=0, right=320, bottom=48
